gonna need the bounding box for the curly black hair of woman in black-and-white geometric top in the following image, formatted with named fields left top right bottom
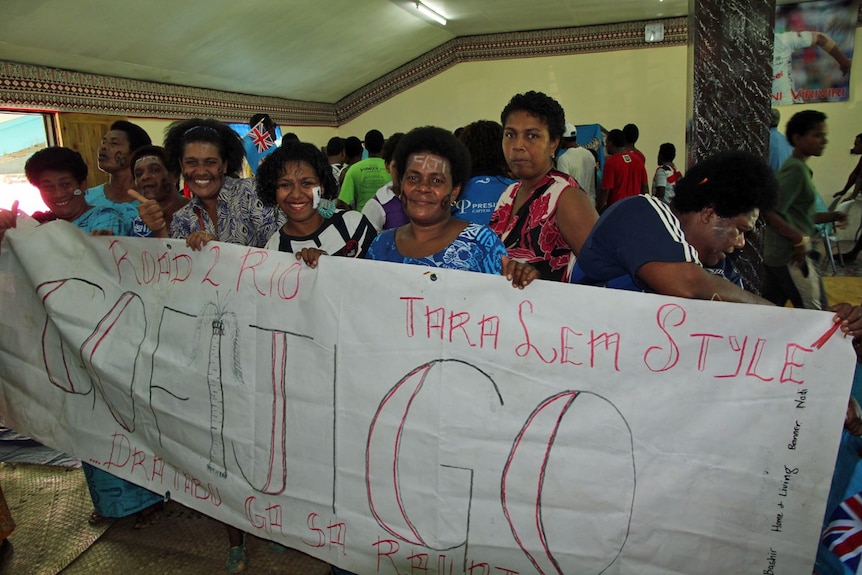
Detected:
left=256, top=142, right=338, bottom=206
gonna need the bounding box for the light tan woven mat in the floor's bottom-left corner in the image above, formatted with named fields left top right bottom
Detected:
left=0, top=463, right=109, bottom=575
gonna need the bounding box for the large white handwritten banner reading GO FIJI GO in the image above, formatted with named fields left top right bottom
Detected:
left=0, top=220, right=855, bottom=575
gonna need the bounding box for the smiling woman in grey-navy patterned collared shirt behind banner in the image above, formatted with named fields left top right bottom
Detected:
left=144, top=118, right=279, bottom=250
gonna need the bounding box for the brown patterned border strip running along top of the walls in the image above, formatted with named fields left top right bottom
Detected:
left=5, top=11, right=862, bottom=126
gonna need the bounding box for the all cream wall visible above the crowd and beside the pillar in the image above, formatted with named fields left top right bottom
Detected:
left=135, top=28, right=862, bottom=209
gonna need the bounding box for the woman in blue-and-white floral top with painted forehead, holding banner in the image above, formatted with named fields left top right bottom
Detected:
left=368, top=126, right=538, bottom=288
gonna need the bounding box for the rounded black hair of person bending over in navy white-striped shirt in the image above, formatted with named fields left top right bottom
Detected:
left=671, top=150, right=778, bottom=218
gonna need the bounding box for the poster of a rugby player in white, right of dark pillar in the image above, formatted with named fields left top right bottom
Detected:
left=772, top=0, right=859, bottom=106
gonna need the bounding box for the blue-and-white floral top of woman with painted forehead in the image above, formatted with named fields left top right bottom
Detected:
left=367, top=224, right=506, bottom=275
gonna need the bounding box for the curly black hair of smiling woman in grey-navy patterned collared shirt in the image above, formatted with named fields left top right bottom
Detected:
left=165, top=118, right=245, bottom=178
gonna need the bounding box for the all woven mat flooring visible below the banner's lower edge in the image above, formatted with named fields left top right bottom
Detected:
left=0, top=463, right=329, bottom=575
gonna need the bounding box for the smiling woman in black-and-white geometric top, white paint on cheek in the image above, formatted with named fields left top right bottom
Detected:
left=257, top=142, right=377, bottom=267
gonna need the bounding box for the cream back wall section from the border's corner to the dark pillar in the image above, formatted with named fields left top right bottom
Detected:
left=339, top=46, right=687, bottom=173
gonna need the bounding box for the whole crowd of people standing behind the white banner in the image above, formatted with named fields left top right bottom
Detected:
left=0, top=91, right=862, bottom=575
